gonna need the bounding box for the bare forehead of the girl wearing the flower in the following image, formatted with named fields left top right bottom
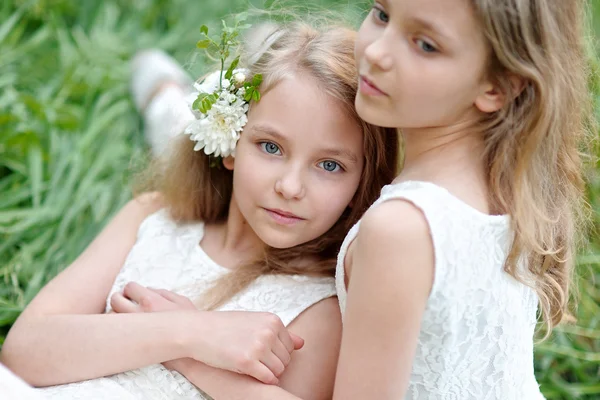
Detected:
left=248, top=74, right=363, bottom=156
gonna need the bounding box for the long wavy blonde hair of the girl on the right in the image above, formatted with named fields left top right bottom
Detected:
left=471, top=0, right=594, bottom=334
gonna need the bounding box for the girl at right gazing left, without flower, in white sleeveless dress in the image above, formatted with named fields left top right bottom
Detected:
left=334, top=0, right=591, bottom=400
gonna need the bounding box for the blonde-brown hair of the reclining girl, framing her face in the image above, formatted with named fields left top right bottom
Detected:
left=149, top=22, right=399, bottom=309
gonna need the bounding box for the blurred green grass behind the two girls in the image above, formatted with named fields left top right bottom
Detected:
left=0, top=0, right=600, bottom=399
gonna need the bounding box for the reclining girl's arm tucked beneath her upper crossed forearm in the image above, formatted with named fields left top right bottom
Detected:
left=115, top=287, right=341, bottom=400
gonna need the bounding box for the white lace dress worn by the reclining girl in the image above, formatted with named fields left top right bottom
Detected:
left=36, top=210, right=335, bottom=400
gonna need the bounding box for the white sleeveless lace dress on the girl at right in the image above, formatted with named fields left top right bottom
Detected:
left=336, top=181, right=543, bottom=400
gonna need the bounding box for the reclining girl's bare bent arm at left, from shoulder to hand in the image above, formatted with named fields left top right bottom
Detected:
left=1, top=194, right=293, bottom=386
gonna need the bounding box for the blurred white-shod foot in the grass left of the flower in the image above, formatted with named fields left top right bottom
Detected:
left=131, top=49, right=194, bottom=156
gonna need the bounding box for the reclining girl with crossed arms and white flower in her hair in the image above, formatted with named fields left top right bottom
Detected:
left=2, top=23, right=398, bottom=399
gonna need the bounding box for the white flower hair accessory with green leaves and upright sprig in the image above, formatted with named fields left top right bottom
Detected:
left=184, top=20, right=262, bottom=157
